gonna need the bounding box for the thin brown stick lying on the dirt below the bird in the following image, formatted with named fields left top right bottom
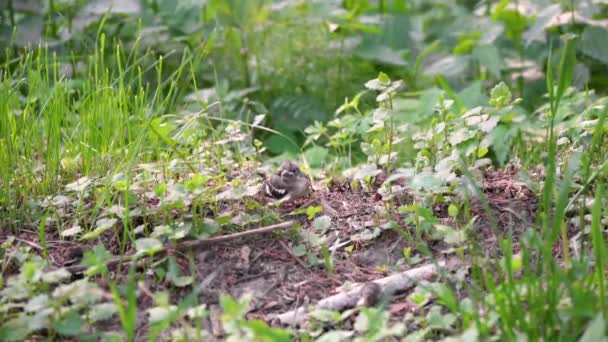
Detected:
left=66, top=221, right=295, bottom=273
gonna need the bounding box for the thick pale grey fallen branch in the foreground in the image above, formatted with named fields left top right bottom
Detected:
left=275, top=261, right=456, bottom=325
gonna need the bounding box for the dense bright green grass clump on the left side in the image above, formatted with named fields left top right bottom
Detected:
left=0, top=34, right=197, bottom=227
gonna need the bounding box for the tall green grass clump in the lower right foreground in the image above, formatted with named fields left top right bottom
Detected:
left=462, top=38, right=607, bottom=341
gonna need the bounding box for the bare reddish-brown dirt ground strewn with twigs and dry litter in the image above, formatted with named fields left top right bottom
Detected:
left=0, top=169, right=537, bottom=337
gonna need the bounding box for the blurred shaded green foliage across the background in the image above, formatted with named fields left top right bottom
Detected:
left=0, top=0, right=608, bottom=150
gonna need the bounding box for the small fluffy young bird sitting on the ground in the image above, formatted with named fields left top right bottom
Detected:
left=264, top=161, right=310, bottom=204
